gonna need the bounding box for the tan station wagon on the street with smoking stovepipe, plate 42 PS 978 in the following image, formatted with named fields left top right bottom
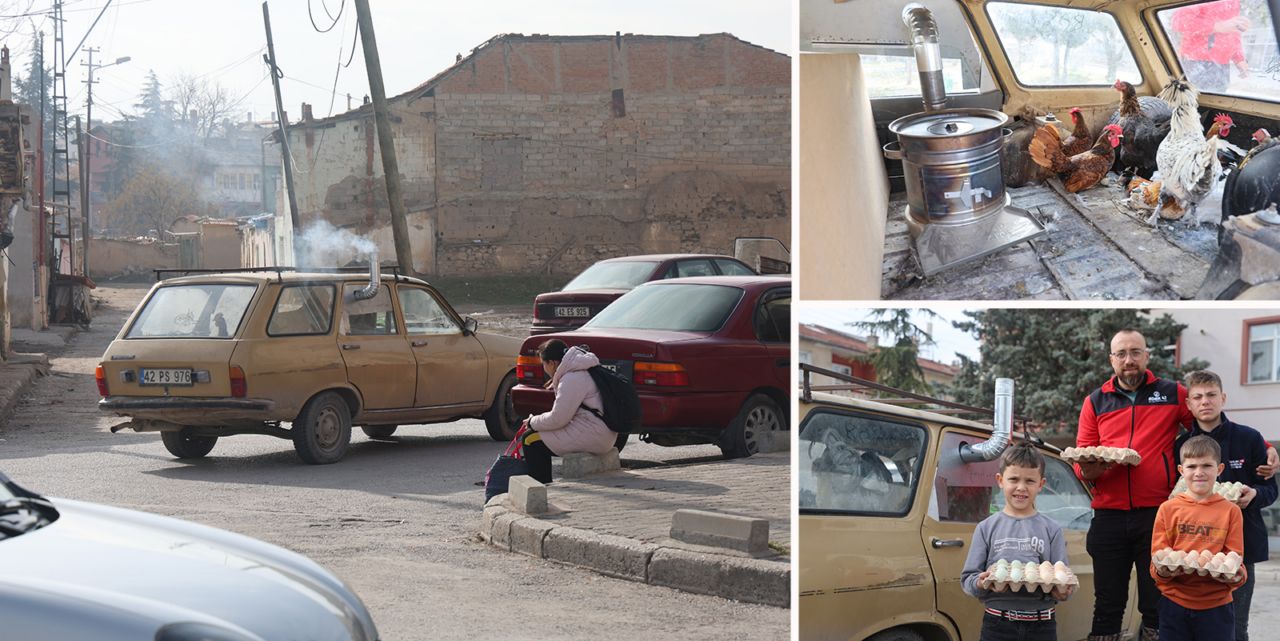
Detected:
left=97, top=269, right=520, bottom=463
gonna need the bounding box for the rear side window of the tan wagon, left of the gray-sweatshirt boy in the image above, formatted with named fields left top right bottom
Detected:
left=799, top=409, right=927, bottom=516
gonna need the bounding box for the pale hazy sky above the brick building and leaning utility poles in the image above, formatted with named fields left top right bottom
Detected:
left=0, top=0, right=792, bottom=127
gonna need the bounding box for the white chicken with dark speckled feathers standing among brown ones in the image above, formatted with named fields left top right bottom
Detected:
left=1147, top=78, right=1231, bottom=226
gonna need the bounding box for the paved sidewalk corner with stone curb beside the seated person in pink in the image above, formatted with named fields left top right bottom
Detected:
left=480, top=452, right=791, bottom=608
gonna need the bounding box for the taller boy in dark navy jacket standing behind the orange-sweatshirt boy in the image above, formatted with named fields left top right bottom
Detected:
left=1174, top=370, right=1276, bottom=641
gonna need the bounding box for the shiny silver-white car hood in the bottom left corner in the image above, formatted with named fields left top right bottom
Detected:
left=0, top=499, right=378, bottom=641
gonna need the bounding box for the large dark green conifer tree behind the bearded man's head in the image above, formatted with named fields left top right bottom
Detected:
left=948, top=310, right=1208, bottom=434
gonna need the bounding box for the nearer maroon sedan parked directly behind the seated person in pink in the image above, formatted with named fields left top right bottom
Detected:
left=511, top=276, right=791, bottom=458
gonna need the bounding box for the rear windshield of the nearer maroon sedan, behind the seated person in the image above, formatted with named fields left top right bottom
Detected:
left=586, top=284, right=744, bottom=331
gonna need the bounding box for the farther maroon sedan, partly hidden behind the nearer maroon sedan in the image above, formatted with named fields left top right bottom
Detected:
left=530, top=253, right=755, bottom=335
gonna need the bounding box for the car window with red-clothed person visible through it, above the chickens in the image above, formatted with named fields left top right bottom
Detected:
left=1156, top=0, right=1280, bottom=102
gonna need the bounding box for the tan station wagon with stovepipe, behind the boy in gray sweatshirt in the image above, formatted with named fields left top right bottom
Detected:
left=797, top=365, right=1139, bottom=641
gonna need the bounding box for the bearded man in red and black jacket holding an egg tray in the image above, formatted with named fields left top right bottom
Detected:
left=1075, top=329, right=1277, bottom=641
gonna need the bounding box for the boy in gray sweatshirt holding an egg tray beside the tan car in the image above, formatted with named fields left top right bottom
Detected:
left=960, top=443, right=1075, bottom=641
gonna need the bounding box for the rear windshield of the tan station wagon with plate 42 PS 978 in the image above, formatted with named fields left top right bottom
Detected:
left=124, top=284, right=256, bottom=338
